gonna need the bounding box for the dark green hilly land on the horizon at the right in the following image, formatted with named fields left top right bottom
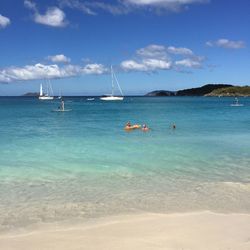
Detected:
left=146, top=84, right=250, bottom=96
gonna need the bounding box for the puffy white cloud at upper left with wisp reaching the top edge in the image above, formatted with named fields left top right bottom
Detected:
left=24, top=0, right=68, bottom=27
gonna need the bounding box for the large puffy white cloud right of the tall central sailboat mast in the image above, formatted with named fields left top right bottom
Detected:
left=120, top=44, right=204, bottom=72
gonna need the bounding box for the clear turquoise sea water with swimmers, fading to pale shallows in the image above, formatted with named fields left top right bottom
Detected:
left=0, top=97, right=250, bottom=230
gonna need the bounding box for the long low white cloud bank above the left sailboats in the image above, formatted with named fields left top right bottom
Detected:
left=0, top=63, right=107, bottom=83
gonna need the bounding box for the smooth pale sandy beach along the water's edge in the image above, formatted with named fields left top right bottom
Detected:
left=0, top=212, right=250, bottom=250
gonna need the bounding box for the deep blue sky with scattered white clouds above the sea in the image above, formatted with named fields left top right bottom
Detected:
left=0, top=0, right=250, bottom=96
